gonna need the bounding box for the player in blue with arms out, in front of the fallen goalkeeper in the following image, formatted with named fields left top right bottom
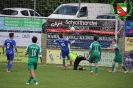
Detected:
left=55, top=34, right=77, bottom=70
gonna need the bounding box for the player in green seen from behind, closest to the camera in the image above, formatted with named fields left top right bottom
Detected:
left=25, top=36, right=43, bottom=85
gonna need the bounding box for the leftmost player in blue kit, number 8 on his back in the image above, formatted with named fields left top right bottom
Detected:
left=2, top=33, right=18, bottom=72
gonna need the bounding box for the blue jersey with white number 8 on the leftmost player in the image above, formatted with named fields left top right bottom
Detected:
left=4, top=39, right=16, bottom=54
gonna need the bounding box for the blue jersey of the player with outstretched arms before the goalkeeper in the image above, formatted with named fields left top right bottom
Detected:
left=55, top=38, right=71, bottom=52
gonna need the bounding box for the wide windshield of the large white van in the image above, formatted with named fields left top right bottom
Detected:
left=53, top=5, right=78, bottom=15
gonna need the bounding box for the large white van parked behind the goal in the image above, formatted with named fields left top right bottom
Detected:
left=49, top=3, right=110, bottom=19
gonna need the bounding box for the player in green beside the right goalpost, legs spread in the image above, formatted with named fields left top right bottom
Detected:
left=108, top=39, right=128, bottom=73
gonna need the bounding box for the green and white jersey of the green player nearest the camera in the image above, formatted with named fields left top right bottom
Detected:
left=26, top=43, right=42, bottom=60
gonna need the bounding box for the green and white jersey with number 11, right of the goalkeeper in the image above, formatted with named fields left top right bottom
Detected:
left=89, top=41, right=101, bottom=55
